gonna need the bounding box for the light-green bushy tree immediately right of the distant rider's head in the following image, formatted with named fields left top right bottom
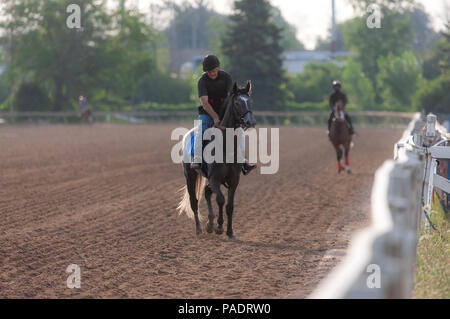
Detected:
left=342, top=59, right=375, bottom=109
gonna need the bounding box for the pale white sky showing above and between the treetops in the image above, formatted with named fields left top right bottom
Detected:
left=132, top=0, right=450, bottom=50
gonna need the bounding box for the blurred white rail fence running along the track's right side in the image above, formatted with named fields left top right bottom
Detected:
left=310, top=113, right=450, bottom=299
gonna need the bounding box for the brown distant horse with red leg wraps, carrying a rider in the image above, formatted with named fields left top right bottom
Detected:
left=330, top=101, right=352, bottom=174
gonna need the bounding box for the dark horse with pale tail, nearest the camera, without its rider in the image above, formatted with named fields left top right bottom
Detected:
left=178, top=82, right=256, bottom=239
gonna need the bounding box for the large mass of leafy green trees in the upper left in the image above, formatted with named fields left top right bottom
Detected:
left=0, top=0, right=167, bottom=111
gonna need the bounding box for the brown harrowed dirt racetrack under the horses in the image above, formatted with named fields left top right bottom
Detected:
left=0, top=124, right=401, bottom=298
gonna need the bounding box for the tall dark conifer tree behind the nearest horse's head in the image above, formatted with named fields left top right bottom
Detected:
left=222, top=0, right=284, bottom=109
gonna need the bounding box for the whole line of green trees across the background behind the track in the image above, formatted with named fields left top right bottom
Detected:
left=0, top=0, right=450, bottom=112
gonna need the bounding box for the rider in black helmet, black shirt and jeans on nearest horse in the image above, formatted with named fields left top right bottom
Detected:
left=191, top=55, right=256, bottom=175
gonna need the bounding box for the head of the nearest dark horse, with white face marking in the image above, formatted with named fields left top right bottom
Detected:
left=224, top=81, right=256, bottom=130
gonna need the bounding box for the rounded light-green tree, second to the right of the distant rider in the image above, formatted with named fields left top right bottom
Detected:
left=377, top=52, right=423, bottom=110
